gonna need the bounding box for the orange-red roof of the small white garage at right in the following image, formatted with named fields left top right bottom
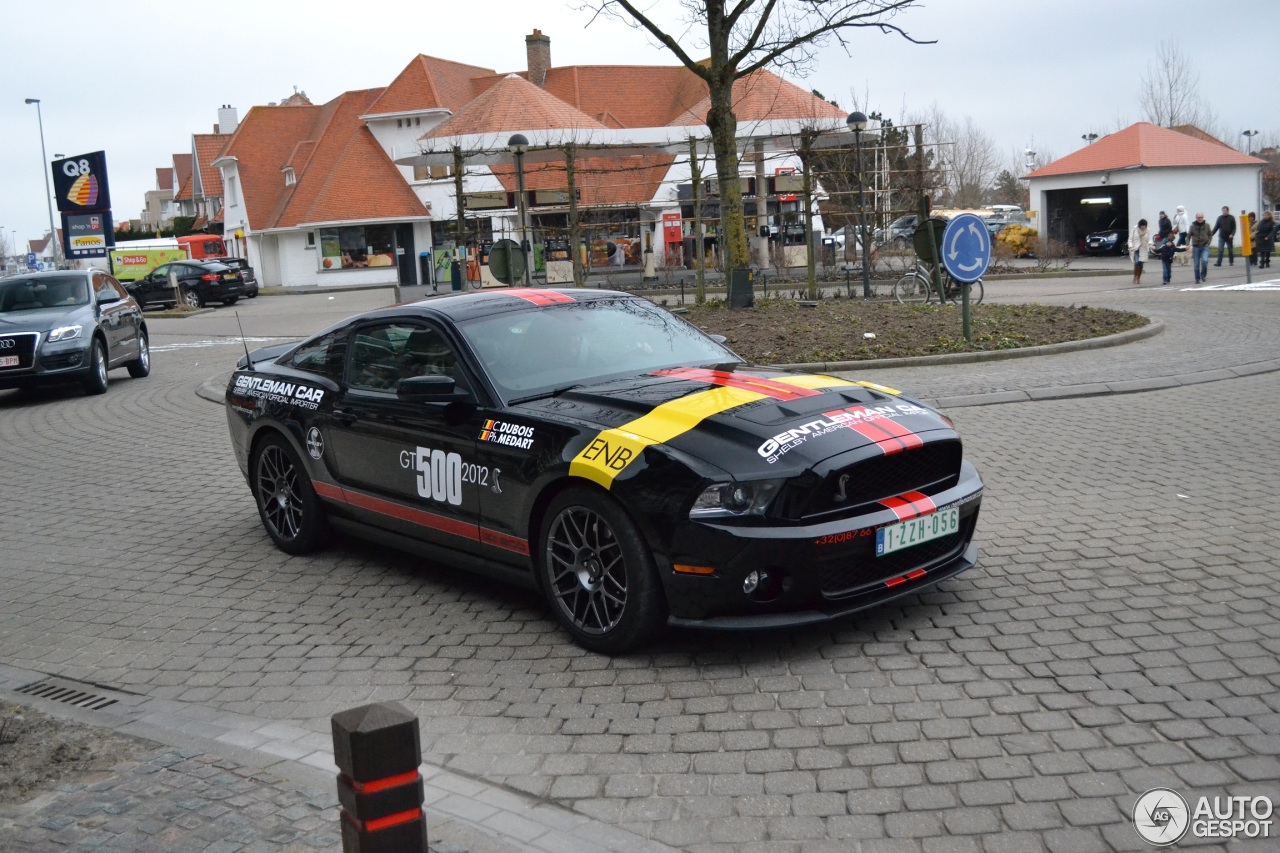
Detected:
left=1027, top=122, right=1263, bottom=178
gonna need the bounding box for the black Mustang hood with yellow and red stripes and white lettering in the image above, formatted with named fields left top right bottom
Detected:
left=517, top=366, right=955, bottom=479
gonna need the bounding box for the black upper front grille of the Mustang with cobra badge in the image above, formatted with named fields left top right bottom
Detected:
left=780, top=438, right=964, bottom=521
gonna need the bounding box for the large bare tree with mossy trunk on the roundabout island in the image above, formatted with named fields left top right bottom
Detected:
left=584, top=0, right=916, bottom=269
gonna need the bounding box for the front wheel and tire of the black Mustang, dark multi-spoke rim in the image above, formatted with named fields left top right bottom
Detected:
left=538, top=487, right=667, bottom=654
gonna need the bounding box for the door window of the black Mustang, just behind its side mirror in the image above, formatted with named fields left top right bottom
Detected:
left=347, top=323, right=468, bottom=392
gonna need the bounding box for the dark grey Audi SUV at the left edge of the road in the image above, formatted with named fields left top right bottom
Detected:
left=0, top=270, right=151, bottom=394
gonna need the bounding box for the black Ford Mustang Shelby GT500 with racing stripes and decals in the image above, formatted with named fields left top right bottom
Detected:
left=227, top=288, right=982, bottom=653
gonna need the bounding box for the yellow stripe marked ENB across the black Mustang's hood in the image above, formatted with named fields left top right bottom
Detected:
left=568, top=375, right=860, bottom=488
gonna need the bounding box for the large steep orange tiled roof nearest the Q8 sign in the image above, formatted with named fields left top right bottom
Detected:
left=227, top=88, right=425, bottom=229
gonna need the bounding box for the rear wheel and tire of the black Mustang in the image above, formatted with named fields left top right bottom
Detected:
left=250, top=435, right=328, bottom=555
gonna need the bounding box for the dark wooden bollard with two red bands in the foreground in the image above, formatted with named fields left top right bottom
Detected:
left=332, top=702, right=426, bottom=853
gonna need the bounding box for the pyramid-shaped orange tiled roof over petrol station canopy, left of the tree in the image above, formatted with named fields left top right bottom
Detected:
left=424, top=74, right=604, bottom=140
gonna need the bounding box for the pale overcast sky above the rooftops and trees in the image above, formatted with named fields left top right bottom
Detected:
left=0, top=0, right=1280, bottom=248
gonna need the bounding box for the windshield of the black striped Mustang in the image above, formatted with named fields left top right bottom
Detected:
left=458, top=298, right=741, bottom=400
